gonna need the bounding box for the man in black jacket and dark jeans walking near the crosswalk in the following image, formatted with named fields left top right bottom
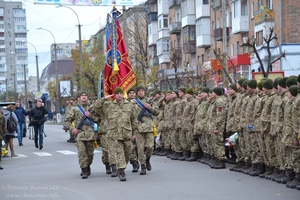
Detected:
left=29, top=99, right=48, bottom=150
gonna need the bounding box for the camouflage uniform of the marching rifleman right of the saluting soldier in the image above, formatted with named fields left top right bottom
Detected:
left=131, top=97, right=159, bottom=168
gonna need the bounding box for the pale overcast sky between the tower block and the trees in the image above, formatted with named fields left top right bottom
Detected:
left=23, top=0, right=121, bottom=76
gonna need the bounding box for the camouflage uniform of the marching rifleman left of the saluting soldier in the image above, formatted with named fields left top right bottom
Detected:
left=65, top=103, right=96, bottom=169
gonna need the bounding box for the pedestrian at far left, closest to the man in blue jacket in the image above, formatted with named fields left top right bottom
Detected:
left=3, top=105, right=18, bottom=157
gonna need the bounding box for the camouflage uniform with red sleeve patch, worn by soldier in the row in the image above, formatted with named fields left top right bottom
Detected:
left=207, top=97, right=226, bottom=161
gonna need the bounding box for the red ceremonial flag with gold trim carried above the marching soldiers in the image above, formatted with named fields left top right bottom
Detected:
left=104, top=16, right=136, bottom=95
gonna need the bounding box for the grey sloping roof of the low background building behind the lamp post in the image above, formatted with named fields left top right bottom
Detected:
left=40, top=58, right=75, bottom=80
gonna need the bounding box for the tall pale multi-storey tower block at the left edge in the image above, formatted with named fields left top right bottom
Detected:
left=0, top=0, right=28, bottom=93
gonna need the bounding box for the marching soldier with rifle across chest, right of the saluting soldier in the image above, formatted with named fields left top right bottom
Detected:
left=131, top=86, right=159, bottom=175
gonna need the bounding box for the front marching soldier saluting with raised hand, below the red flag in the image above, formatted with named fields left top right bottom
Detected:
left=94, top=87, right=138, bottom=181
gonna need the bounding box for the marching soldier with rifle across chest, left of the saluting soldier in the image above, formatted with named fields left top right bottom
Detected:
left=65, top=92, right=96, bottom=179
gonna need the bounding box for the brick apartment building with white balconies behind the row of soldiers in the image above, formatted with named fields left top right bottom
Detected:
left=145, top=0, right=300, bottom=89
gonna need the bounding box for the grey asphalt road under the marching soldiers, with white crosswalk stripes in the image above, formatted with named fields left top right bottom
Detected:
left=0, top=125, right=300, bottom=200
